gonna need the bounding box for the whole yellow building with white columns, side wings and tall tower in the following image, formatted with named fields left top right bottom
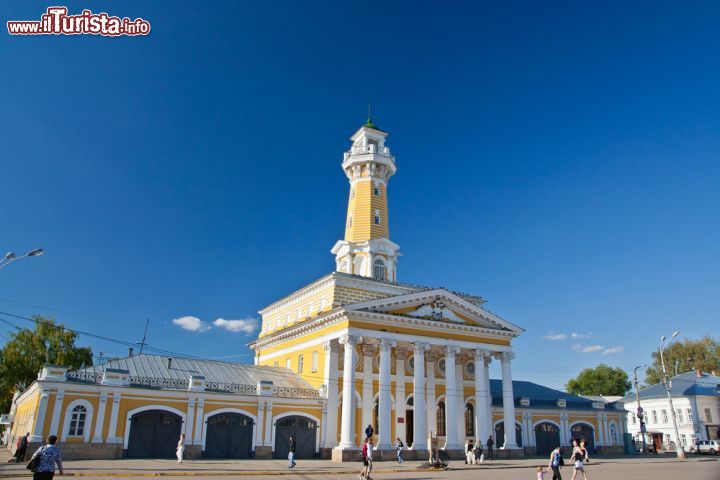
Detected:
left=4, top=120, right=625, bottom=461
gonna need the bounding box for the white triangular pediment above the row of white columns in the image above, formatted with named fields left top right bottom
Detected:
left=345, top=289, right=523, bottom=335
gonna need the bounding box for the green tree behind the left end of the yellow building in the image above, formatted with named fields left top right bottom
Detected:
left=0, top=316, right=92, bottom=412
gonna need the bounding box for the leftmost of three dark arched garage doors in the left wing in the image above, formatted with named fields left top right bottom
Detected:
left=127, top=410, right=182, bottom=458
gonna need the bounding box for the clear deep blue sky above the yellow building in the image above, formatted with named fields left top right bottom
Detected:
left=0, top=1, right=720, bottom=387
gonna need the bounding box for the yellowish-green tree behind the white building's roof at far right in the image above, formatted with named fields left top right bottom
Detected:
left=645, top=335, right=720, bottom=385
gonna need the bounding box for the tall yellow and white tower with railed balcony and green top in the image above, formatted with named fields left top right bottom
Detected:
left=331, top=118, right=400, bottom=282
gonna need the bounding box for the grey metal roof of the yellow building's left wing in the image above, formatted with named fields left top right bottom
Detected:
left=69, top=353, right=312, bottom=388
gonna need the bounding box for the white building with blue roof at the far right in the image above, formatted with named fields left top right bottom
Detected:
left=624, top=371, right=720, bottom=452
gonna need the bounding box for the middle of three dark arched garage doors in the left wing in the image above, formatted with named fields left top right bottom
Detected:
left=205, top=412, right=253, bottom=458
